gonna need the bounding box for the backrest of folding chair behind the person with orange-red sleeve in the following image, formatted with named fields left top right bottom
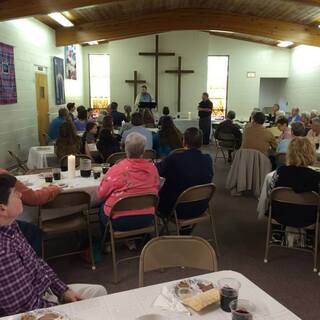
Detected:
left=39, top=191, right=91, bottom=224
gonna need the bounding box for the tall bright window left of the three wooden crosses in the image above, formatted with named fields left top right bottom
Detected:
left=89, top=54, right=110, bottom=109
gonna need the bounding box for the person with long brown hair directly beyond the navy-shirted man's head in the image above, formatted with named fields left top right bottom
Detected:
left=153, top=117, right=182, bottom=158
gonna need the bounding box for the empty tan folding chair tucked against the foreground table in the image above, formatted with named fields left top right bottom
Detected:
left=139, top=236, right=218, bottom=287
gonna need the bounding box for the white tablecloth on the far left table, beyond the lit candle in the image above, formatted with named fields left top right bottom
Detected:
left=27, top=146, right=57, bottom=169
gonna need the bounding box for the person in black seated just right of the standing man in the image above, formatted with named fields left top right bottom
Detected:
left=214, top=110, right=242, bottom=162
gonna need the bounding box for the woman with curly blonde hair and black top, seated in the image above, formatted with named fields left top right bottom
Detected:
left=269, top=137, right=320, bottom=227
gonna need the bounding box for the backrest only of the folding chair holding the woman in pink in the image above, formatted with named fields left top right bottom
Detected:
left=110, top=193, right=158, bottom=218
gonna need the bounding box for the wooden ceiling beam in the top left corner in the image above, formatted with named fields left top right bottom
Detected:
left=0, top=0, right=124, bottom=21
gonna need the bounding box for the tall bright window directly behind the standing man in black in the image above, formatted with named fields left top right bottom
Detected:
left=207, top=56, right=229, bottom=119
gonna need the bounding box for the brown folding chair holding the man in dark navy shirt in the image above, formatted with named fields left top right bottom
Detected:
left=164, top=183, right=219, bottom=256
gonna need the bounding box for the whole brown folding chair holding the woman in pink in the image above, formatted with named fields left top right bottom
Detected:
left=101, top=193, right=158, bottom=283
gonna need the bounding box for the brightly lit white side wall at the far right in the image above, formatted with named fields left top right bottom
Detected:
left=285, top=46, right=320, bottom=111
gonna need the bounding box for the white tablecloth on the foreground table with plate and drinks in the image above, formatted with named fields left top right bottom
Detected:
left=4, top=271, right=300, bottom=320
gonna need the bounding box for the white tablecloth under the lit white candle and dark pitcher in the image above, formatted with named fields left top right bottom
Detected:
left=17, top=171, right=101, bottom=223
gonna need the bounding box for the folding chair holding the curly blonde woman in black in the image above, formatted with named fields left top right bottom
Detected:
left=264, top=187, right=320, bottom=272
